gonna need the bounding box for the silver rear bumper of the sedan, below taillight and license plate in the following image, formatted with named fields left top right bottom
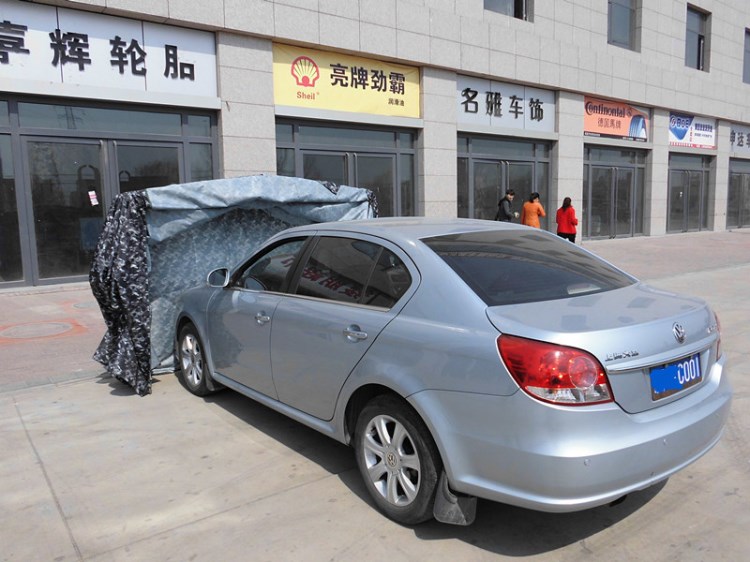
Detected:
left=410, top=354, right=731, bottom=512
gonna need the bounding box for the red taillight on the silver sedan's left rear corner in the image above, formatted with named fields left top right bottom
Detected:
left=497, top=335, right=613, bottom=406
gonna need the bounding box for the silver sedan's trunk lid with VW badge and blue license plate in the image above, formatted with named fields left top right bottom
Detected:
left=487, top=283, right=718, bottom=413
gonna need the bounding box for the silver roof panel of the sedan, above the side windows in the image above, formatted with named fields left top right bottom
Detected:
left=285, top=217, right=528, bottom=242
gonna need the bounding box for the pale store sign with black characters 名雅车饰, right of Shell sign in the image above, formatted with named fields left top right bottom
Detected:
left=456, top=76, right=555, bottom=133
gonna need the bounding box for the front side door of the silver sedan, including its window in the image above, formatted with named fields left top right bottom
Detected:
left=208, top=239, right=305, bottom=398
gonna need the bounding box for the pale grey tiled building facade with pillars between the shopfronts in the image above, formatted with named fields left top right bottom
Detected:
left=11, top=0, right=750, bottom=235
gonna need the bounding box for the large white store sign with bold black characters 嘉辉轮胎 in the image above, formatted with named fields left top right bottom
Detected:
left=0, top=0, right=219, bottom=107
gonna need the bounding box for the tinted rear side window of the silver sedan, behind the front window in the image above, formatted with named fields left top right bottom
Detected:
left=296, top=237, right=411, bottom=308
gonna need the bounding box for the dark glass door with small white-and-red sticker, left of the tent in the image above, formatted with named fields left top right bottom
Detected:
left=24, top=139, right=106, bottom=283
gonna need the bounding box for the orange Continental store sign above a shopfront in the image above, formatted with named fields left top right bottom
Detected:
left=583, top=96, right=649, bottom=142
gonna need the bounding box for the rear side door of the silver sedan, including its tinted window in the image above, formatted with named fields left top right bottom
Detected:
left=271, top=236, right=412, bottom=420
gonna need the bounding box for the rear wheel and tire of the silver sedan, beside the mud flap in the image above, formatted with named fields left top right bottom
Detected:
left=354, top=395, right=442, bottom=525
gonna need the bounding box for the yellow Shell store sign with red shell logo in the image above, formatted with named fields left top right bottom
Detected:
left=273, top=45, right=420, bottom=118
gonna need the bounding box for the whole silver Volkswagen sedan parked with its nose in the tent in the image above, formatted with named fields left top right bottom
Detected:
left=176, top=218, right=731, bottom=525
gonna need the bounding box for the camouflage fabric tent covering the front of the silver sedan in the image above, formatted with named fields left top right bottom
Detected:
left=89, top=176, right=377, bottom=396
